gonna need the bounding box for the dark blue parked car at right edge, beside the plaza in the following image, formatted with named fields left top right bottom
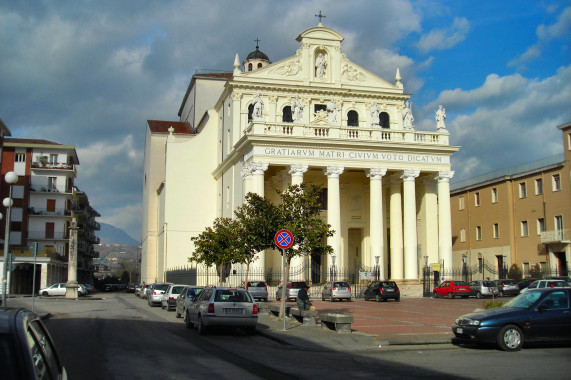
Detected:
left=452, top=288, right=571, bottom=351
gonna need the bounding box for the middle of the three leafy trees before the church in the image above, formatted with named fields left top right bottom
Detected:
left=234, top=193, right=280, bottom=282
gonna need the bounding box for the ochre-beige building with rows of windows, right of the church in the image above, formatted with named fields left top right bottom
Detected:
left=450, top=123, right=571, bottom=277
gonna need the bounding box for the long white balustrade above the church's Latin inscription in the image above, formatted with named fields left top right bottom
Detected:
left=244, top=121, right=449, bottom=145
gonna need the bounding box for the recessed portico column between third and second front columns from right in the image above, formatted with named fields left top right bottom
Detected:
left=389, top=175, right=404, bottom=280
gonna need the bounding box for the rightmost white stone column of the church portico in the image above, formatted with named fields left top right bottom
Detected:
left=436, top=171, right=454, bottom=269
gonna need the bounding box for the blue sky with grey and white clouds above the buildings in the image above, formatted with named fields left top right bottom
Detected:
left=0, top=0, right=571, bottom=239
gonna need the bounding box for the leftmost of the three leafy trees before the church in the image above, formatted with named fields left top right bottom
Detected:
left=189, top=218, right=243, bottom=283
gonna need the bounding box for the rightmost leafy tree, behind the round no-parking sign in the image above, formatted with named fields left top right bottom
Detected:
left=274, top=184, right=335, bottom=315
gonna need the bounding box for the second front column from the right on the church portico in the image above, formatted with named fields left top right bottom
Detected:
left=402, top=169, right=420, bottom=280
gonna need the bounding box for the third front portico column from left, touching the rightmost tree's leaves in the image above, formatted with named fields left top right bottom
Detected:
left=323, top=166, right=346, bottom=274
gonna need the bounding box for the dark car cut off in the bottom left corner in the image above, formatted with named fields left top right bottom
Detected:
left=0, top=307, right=67, bottom=380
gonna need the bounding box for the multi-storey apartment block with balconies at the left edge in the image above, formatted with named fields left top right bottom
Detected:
left=0, top=138, right=99, bottom=294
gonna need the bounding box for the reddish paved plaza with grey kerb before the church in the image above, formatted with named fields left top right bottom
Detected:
left=258, top=298, right=488, bottom=351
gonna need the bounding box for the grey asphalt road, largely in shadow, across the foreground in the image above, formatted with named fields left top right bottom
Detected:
left=20, top=293, right=571, bottom=380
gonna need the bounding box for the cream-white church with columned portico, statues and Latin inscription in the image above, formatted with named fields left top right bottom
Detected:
left=141, top=23, right=459, bottom=284
